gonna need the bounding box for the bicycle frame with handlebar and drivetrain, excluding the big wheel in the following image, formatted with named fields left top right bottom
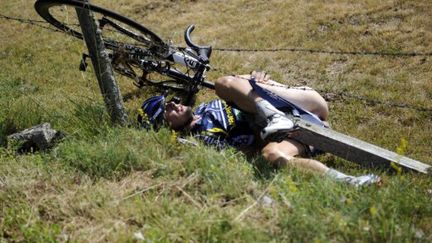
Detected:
left=105, top=22, right=214, bottom=104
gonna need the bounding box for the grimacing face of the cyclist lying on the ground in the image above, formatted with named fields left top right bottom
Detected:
left=165, top=102, right=193, bottom=129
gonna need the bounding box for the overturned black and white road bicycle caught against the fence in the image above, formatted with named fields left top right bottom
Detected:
left=34, top=0, right=214, bottom=105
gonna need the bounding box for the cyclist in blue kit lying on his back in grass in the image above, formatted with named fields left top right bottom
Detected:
left=138, top=72, right=380, bottom=186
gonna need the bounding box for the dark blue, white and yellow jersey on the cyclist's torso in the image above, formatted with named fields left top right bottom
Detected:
left=191, top=100, right=255, bottom=148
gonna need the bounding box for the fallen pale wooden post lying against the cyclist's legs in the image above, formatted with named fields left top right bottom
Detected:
left=290, top=117, right=432, bottom=174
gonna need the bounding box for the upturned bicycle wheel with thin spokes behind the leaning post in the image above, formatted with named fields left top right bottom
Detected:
left=35, top=0, right=167, bottom=51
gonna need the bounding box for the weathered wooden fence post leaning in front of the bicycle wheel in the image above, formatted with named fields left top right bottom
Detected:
left=76, top=4, right=127, bottom=126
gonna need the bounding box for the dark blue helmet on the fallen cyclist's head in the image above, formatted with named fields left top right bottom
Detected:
left=138, top=95, right=165, bottom=130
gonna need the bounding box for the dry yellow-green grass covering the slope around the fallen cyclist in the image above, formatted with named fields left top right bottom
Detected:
left=0, top=0, right=432, bottom=242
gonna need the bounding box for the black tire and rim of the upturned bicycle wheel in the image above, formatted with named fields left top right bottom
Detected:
left=34, top=0, right=166, bottom=49
